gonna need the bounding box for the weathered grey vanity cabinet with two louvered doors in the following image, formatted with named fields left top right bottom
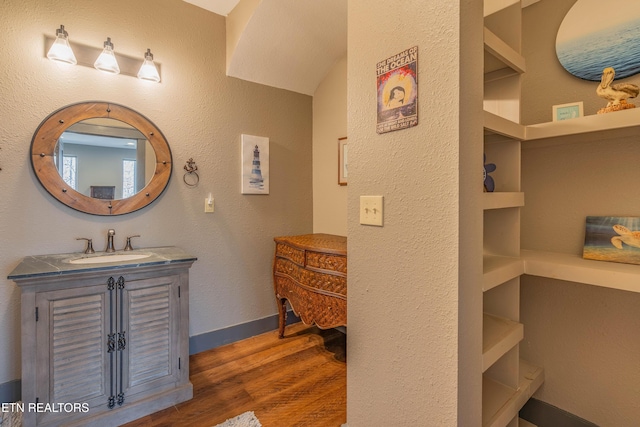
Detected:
left=9, top=248, right=195, bottom=427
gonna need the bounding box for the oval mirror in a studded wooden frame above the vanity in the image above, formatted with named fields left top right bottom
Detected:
left=31, top=102, right=172, bottom=215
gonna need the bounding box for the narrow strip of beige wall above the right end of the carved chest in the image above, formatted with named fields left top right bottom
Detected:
left=313, top=56, right=348, bottom=236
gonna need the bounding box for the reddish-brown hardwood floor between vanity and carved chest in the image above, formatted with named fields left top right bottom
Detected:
left=125, top=323, right=347, bottom=427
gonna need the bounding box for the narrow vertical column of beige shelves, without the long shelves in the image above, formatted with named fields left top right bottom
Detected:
left=482, top=0, right=544, bottom=427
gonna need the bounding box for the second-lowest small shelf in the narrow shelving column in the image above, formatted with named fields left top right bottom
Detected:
left=482, top=313, right=524, bottom=372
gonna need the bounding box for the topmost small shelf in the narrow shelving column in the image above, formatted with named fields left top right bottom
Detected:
left=484, top=27, right=526, bottom=82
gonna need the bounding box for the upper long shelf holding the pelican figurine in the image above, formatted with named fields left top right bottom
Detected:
left=524, top=108, right=640, bottom=141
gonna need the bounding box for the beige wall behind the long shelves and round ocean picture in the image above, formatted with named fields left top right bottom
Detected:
left=520, top=0, right=640, bottom=427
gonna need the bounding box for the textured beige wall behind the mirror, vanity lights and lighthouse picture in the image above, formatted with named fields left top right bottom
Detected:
left=0, top=0, right=312, bottom=383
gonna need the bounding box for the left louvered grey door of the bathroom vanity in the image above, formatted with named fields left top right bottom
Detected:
left=36, top=280, right=114, bottom=424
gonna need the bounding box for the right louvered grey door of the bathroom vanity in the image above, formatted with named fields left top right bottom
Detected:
left=118, top=275, right=181, bottom=401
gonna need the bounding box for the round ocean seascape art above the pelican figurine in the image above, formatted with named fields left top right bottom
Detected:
left=556, top=0, right=640, bottom=81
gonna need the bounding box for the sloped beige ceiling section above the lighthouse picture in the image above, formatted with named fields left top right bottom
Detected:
left=184, top=0, right=347, bottom=96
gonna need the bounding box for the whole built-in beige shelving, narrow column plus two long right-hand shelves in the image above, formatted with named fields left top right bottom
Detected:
left=482, top=0, right=640, bottom=427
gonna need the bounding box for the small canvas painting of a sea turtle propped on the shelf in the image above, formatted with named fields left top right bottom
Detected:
left=582, top=216, right=640, bottom=264
